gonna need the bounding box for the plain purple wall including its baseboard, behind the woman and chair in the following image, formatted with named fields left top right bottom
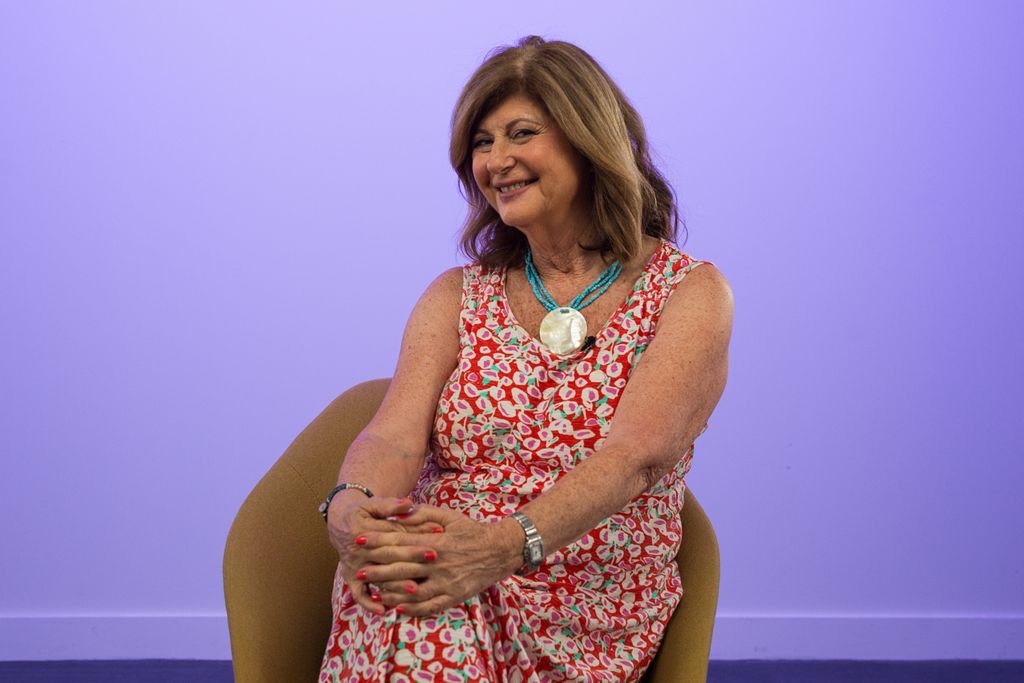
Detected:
left=0, top=0, right=1024, bottom=659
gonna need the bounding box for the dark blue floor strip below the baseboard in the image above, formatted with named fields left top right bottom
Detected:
left=0, top=659, right=1024, bottom=683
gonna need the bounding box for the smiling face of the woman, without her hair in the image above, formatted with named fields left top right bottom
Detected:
left=472, top=95, right=591, bottom=233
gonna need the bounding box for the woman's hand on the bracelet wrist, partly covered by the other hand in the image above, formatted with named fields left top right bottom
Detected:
left=327, top=497, right=440, bottom=614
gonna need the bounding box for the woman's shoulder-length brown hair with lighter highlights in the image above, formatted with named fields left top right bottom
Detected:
left=449, top=36, right=685, bottom=268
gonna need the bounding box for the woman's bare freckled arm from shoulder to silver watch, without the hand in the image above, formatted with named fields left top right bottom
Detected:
left=516, top=265, right=733, bottom=552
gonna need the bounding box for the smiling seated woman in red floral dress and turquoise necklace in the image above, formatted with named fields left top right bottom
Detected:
left=321, top=37, right=732, bottom=681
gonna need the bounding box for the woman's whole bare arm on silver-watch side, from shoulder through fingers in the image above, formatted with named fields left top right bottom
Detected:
left=368, top=265, right=733, bottom=615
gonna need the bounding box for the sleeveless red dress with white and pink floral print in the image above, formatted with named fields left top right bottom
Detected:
left=319, top=242, right=710, bottom=683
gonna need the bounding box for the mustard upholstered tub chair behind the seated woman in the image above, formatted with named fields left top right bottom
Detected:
left=224, top=380, right=719, bottom=683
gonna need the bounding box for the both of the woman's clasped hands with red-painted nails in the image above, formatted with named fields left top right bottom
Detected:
left=328, top=498, right=522, bottom=616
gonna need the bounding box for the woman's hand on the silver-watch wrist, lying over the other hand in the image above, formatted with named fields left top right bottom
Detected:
left=364, top=505, right=524, bottom=616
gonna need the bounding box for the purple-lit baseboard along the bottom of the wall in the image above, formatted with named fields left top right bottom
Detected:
left=0, top=613, right=1024, bottom=660
